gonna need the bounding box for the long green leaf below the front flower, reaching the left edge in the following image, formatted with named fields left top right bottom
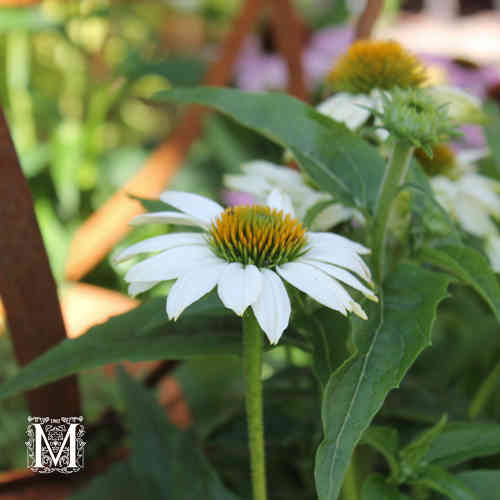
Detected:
left=0, top=294, right=241, bottom=398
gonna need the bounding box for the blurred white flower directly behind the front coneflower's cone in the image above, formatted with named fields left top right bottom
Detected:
left=224, top=160, right=362, bottom=231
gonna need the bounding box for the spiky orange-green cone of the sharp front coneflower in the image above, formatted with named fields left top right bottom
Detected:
left=209, top=205, right=307, bottom=267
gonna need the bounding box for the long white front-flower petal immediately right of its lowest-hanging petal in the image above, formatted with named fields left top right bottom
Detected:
left=277, top=262, right=353, bottom=315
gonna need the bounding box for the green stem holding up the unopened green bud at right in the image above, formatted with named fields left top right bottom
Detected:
left=372, top=140, right=413, bottom=286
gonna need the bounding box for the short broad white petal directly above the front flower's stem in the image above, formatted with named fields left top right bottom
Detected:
left=217, top=262, right=262, bottom=316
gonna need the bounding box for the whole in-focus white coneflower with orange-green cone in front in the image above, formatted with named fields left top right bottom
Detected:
left=116, top=191, right=377, bottom=344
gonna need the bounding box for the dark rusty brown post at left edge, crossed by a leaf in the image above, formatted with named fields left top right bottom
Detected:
left=0, top=109, right=80, bottom=417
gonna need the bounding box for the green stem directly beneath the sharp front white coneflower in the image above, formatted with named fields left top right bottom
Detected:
left=243, top=310, right=267, bottom=500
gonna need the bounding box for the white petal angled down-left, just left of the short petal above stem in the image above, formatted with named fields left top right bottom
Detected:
left=167, top=262, right=227, bottom=321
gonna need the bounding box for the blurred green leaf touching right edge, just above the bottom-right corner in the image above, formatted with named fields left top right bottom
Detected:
left=426, top=422, right=500, bottom=467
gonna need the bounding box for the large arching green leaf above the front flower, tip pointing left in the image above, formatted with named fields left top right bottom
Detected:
left=153, top=87, right=385, bottom=208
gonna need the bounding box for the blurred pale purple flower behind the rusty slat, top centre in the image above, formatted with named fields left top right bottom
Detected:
left=235, top=26, right=353, bottom=92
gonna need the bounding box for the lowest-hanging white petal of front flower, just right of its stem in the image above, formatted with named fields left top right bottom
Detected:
left=252, top=269, right=291, bottom=344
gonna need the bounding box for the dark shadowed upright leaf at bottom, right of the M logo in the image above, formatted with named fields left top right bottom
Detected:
left=73, top=369, right=237, bottom=500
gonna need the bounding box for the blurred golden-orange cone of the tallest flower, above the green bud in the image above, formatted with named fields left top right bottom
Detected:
left=327, top=40, right=427, bottom=94
